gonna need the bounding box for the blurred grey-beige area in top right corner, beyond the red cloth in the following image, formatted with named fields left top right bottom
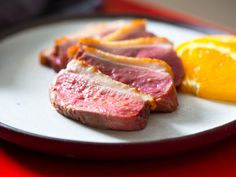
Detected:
left=133, top=0, right=236, bottom=30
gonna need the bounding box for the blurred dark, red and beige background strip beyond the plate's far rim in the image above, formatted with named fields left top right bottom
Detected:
left=0, top=0, right=236, bottom=31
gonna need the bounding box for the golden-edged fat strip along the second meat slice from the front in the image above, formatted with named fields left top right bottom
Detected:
left=85, top=48, right=169, bottom=73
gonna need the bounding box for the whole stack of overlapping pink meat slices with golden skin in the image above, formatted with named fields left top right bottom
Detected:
left=44, top=20, right=184, bottom=130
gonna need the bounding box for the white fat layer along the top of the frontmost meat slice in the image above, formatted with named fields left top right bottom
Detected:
left=66, top=60, right=153, bottom=102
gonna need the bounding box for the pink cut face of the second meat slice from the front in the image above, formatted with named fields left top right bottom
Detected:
left=81, top=54, right=172, bottom=98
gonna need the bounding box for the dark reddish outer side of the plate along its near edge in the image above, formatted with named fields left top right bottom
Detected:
left=0, top=120, right=236, bottom=160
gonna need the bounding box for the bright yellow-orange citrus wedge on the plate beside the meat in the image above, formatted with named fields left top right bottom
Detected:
left=176, top=35, right=236, bottom=102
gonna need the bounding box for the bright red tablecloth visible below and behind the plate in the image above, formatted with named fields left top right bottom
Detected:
left=0, top=0, right=236, bottom=177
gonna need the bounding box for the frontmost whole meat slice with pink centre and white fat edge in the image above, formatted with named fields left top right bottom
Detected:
left=50, top=60, right=153, bottom=130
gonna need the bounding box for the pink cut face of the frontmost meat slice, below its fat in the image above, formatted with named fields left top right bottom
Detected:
left=53, top=72, right=145, bottom=118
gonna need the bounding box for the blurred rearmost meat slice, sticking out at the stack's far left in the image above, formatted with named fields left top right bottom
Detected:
left=39, top=21, right=125, bottom=72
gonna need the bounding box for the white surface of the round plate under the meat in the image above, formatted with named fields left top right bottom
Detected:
left=0, top=17, right=236, bottom=159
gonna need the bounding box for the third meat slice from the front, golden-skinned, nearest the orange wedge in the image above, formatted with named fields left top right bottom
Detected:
left=79, top=37, right=184, bottom=86
